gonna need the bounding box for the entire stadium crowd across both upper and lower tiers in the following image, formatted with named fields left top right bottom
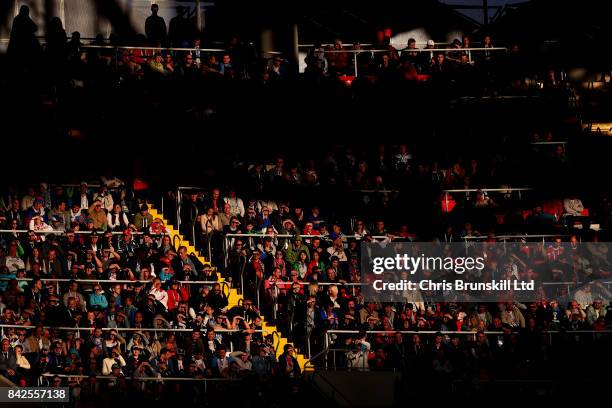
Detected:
left=0, top=0, right=612, bottom=405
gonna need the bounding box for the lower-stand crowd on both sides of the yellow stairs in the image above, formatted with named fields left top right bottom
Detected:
left=0, top=135, right=612, bottom=397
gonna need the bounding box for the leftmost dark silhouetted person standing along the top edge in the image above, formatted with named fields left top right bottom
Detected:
left=7, top=5, right=42, bottom=66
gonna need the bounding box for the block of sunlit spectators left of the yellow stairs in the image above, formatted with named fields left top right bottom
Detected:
left=0, top=181, right=300, bottom=404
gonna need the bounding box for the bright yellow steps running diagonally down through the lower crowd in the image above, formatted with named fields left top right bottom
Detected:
left=148, top=203, right=313, bottom=371
